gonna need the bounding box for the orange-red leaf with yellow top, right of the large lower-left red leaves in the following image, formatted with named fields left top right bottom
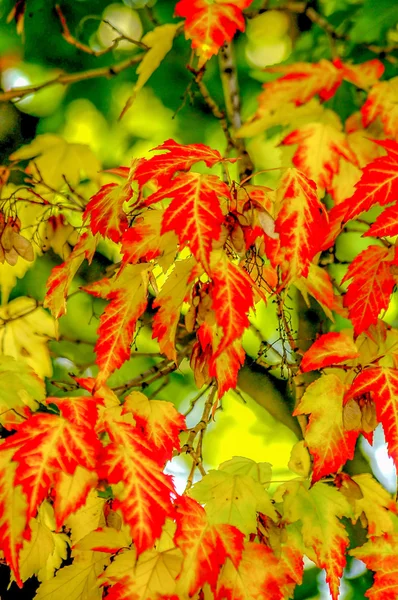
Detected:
left=123, top=392, right=186, bottom=466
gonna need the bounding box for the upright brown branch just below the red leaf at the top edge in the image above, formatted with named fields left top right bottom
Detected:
left=219, top=44, right=254, bottom=180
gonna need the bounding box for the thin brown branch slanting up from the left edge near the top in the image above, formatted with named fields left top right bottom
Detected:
left=0, top=53, right=145, bottom=102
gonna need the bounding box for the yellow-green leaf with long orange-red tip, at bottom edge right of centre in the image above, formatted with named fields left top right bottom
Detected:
left=275, top=480, right=352, bottom=600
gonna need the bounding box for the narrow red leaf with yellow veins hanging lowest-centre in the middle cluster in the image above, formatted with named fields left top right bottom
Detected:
left=211, top=252, right=254, bottom=360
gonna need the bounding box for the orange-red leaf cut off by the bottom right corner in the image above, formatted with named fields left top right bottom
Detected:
left=350, top=533, right=398, bottom=600
